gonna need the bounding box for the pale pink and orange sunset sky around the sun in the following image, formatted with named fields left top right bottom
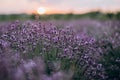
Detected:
left=0, top=0, right=120, bottom=14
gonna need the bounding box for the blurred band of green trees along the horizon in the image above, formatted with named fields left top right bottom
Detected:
left=0, top=11, right=120, bottom=21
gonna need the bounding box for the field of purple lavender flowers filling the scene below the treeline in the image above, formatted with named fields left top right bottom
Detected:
left=0, top=18, right=120, bottom=80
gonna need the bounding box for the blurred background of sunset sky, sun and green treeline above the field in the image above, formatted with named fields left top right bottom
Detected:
left=0, top=0, right=120, bottom=21
